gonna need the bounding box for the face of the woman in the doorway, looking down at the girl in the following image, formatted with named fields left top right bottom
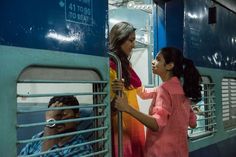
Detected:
left=121, top=32, right=135, bottom=56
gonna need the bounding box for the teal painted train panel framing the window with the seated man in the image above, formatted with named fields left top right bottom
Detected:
left=0, top=45, right=111, bottom=157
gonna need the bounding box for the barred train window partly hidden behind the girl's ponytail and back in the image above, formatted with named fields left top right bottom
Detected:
left=188, top=76, right=216, bottom=140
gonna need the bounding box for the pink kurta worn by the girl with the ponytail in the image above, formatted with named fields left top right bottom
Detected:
left=139, top=77, right=196, bottom=157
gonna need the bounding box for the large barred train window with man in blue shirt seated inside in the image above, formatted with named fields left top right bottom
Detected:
left=17, top=67, right=109, bottom=157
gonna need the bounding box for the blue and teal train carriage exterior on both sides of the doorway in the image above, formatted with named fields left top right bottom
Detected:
left=0, top=0, right=236, bottom=157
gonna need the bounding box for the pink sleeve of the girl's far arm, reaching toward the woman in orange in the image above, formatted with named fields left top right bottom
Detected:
left=137, top=86, right=156, bottom=99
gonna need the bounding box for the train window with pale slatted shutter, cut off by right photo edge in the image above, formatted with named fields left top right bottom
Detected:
left=221, top=78, right=236, bottom=130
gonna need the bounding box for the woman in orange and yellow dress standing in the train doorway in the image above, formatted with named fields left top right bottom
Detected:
left=109, top=22, right=145, bottom=157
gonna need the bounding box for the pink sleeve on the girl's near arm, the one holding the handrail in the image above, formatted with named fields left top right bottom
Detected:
left=151, top=88, right=172, bottom=129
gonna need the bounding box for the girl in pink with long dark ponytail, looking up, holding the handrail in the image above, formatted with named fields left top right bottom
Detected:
left=113, top=47, right=201, bottom=157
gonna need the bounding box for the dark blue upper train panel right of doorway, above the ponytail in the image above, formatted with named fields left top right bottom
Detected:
left=184, top=0, right=236, bottom=71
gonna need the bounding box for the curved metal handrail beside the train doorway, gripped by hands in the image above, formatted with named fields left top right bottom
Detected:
left=108, top=52, right=123, bottom=157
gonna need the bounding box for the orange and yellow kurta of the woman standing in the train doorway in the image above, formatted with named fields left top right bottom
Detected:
left=110, top=68, right=145, bottom=157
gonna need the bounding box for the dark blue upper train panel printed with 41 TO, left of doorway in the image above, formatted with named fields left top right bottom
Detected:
left=0, top=0, right=108, bottom=56
